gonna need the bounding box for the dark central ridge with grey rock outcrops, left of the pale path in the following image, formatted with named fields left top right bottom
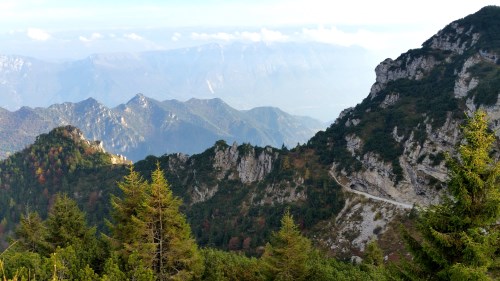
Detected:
left=135, top=141, right=343, bottom=254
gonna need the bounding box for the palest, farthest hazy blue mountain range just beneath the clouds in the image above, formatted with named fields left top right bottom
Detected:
left=0, top=43, right=376, bottom=120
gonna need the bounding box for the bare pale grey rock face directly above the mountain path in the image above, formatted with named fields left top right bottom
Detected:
left=333, top=110, right=460, bottom=205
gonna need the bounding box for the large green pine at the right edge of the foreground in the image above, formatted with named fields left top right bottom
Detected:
left=402, top=111, right=500, bottom=280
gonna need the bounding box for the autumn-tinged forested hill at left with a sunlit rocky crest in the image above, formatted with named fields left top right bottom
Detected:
left=0, top=126, right=130, bottom=246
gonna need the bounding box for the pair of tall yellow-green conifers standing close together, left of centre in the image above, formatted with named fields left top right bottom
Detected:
left=112, top=164, right=203, bottom=280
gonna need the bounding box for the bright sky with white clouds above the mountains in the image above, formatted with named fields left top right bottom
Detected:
left=0, top=0, right=500, bottom=118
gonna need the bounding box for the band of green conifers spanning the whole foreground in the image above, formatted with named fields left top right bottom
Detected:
left=0, top=111, right=500, bottom=280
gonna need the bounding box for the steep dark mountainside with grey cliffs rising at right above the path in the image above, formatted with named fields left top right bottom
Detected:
left=320, top=7, right=500, bottom=205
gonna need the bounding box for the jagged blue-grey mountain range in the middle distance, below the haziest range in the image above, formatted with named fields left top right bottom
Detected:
left=0, top=94, right=326, bottom=160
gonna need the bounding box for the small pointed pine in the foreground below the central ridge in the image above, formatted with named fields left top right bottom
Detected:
left=262, top=210, right=312, bottom=280
